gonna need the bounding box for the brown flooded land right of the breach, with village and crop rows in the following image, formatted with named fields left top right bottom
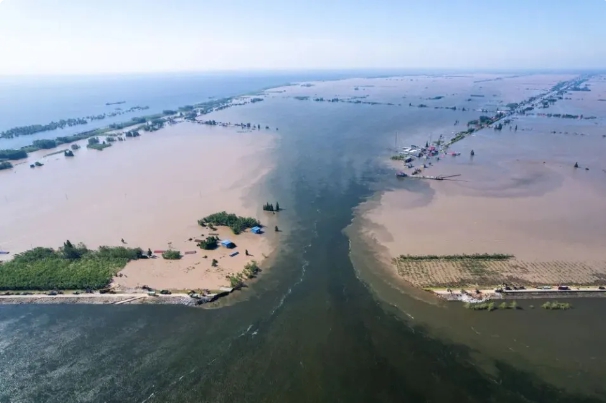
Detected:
left=350, top=76, right=606, bottom=302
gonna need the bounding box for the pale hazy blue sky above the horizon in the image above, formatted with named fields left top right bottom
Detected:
left=0, top=0, right=606, bottom=74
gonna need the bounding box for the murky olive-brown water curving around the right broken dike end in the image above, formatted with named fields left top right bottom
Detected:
left=345, top=208, right=606, bottom=395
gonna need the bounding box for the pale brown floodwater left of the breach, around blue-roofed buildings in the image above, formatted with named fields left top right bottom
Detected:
left=0, top=123, right=275, bottom=289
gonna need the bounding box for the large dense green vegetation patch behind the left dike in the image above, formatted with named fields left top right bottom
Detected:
left=0, top=240, right=143, bottom=290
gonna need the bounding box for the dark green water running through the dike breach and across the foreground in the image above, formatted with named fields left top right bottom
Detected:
left=0, top=83, right=597, bottom=402
